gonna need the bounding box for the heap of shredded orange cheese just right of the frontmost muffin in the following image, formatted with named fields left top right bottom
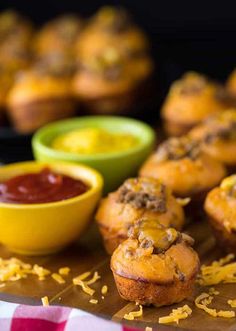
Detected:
left=197, top=254, right=236, bottom=286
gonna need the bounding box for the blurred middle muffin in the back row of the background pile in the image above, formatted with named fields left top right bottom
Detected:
left=34, top=15, right=83, bottom=57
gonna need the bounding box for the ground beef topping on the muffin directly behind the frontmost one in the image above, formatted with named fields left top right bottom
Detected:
left=117, top=178, right=166, bottom=213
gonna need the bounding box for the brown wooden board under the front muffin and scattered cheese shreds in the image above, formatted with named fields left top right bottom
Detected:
left=0, top=222, right=236, bottom=331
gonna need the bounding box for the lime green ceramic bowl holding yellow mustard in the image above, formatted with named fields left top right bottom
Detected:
left=32, top=116, right=155, bottom=193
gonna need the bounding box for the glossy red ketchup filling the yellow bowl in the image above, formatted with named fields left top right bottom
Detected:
left=0, top=168, right=88, bottom=204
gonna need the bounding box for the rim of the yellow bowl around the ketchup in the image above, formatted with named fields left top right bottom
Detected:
left=0, top=160, right=104, bottom=209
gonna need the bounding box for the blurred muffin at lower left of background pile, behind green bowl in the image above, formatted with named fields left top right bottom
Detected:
left=7, top=68, right=76, bottom=133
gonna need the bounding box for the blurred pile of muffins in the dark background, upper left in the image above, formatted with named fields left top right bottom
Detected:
left=0, top=7, right=153, bottom=133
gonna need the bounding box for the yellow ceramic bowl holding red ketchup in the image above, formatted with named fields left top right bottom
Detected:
left=0, top=161, right=103, bottom=255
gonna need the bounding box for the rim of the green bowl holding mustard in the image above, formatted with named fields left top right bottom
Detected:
left=32, top=115, right=156, bottom=162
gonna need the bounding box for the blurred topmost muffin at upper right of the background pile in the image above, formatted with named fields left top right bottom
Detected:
left=76, top=6, right=149, bottom=61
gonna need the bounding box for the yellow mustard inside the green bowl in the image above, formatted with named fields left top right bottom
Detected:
left=51, top=128, right=138, bottom=155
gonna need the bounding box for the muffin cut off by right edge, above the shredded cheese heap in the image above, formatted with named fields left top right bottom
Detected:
left=205, top=175, right=236, bottom=254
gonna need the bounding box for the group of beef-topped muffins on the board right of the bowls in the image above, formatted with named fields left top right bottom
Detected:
left=93, top=72, right=236, bottom=306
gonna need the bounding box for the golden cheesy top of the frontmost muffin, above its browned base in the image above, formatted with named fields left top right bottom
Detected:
left=111, top=219, right=199, bottom=284
